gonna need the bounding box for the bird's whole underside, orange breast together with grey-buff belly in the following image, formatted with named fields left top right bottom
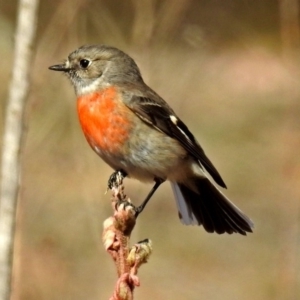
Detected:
left=77, top=87, right=187, bottom=181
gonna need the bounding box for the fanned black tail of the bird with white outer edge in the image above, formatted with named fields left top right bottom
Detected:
left=172, top=178, right=253, bottom=235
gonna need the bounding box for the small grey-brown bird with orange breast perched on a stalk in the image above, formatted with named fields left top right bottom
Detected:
left=49, top=45, right=253, bottom=235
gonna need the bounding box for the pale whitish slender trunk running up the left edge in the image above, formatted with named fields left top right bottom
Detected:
left=0, top=0, right=39, bottom=300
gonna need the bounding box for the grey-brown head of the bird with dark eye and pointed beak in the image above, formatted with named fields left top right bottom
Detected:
left=49, top=45, right=143, bottom=96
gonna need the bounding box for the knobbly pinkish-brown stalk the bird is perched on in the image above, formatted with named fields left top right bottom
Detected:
left=102, top=180, right=152, bottom=300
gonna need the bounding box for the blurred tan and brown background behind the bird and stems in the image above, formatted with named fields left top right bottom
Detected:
left=0, top=0, right=300, bottom=300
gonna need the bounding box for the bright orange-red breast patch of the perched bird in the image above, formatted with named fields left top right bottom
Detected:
left=77, top=87, right=131, bottom=156
